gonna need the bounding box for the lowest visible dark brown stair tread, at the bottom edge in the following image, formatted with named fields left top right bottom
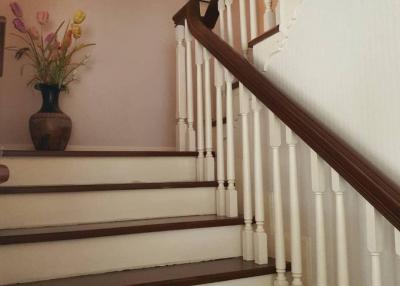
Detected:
left=9, top=257, right=276, bottom=286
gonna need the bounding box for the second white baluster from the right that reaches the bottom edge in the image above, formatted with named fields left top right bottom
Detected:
left=331, top=168, right=350, bottom=286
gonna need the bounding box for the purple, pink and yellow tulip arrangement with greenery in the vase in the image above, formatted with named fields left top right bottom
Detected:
left=8, top=2, right=94, bottom=90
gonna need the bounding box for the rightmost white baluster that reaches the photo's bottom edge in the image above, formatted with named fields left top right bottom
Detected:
left=365, top=201, right=382, bottom=286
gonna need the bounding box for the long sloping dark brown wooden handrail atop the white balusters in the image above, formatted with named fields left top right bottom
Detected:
left=174, top=0, right=400, bottom=230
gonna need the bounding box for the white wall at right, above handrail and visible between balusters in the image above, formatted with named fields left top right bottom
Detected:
left=250, top=0, right=400, bottom=286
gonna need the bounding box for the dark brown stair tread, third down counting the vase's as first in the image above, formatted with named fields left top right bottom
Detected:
left=0, top=215, right=243, bottom=245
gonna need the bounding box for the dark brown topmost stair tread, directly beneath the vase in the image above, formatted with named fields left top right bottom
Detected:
left=3, top=150, right=198, bottom=157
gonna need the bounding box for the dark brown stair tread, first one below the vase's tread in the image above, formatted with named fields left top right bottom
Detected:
left=0, top=181, right=218, bottom=195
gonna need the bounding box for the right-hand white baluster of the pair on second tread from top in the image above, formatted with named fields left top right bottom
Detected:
left=203, top=48, right=215, bottom=181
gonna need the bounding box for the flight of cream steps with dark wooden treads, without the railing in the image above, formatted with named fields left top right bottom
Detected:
left=0, top=151, right=275, bottom=286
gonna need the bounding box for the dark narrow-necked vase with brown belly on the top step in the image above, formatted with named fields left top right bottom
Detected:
left=29, top=84, right=72, bottom=151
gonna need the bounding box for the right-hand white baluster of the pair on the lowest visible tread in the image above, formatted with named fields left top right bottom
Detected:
left=251, top=96, right=268, bottom=264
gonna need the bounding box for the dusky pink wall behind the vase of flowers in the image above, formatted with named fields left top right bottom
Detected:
left=0, top=0, right=186, bottom=149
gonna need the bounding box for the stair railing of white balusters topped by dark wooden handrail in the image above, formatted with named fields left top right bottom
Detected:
left=174, top=0, right=400, bottom=286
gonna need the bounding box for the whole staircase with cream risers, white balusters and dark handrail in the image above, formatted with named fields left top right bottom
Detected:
left=0, top=0, right=400, bottom=286
